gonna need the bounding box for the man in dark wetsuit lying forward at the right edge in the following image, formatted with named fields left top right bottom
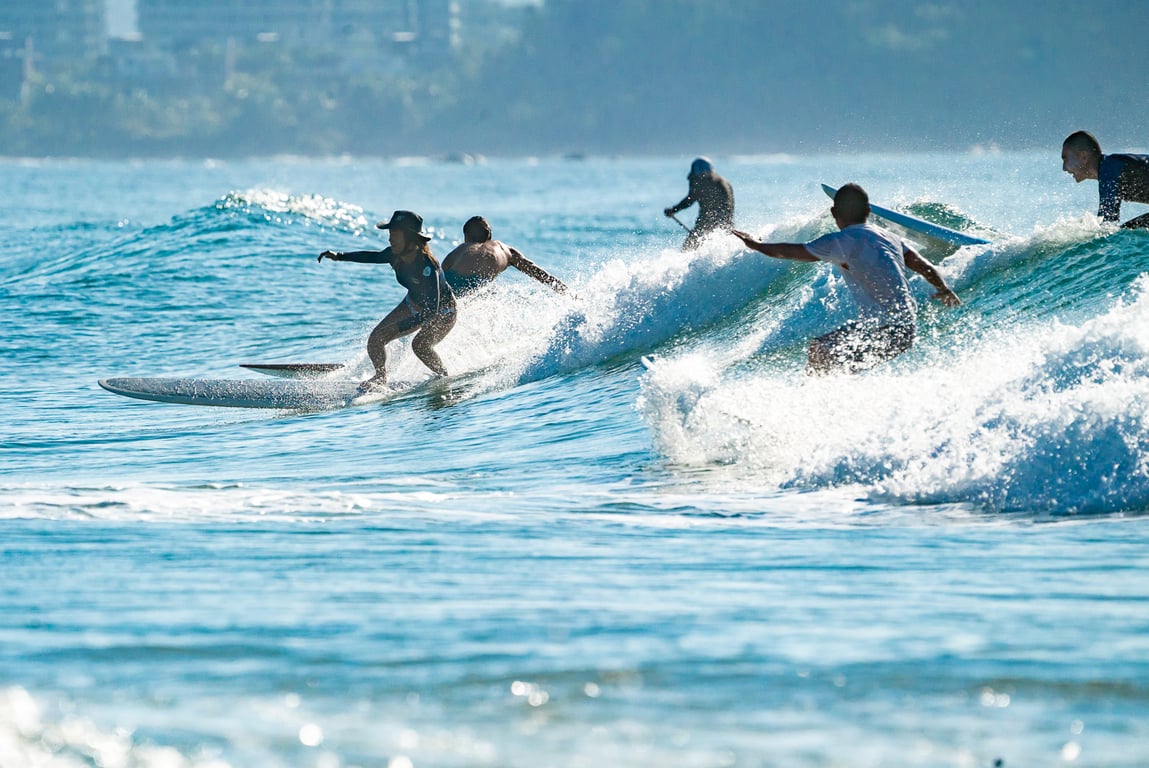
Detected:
left=1062, top=131, right=1149, bottom=229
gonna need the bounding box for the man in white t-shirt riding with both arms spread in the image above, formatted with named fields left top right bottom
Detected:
left=733, top=184, right=962, bottom=374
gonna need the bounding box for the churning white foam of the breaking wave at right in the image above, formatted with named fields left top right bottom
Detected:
left=640, top=278, right=1149, bottom=513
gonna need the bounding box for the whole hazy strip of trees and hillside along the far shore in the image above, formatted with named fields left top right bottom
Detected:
left=0, top=0, right=1149, bottom=156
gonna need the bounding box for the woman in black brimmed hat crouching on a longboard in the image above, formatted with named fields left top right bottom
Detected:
left=319, top=210, right=455, bottom=391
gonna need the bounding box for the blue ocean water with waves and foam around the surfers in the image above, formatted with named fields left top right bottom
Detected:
left=0, top=152, right=1149, bottom=768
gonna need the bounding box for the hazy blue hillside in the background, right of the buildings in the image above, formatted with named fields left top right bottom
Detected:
left=450, top=0, right=1149, bottom=152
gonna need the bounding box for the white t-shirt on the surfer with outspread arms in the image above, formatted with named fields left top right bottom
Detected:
left=805, top=224, right=917, bottom=325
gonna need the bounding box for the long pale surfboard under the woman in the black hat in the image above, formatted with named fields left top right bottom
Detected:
left=100, top=378, right=386, bottom=410
